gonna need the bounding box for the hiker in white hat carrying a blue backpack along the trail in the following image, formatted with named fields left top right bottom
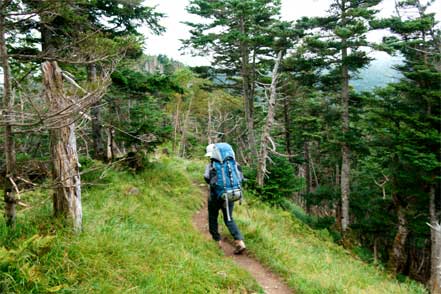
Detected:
left=204, top=143, right=246, bottom=254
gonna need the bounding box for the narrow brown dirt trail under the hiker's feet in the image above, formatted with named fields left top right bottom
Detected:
left=193, top=188, right=294, bottom=294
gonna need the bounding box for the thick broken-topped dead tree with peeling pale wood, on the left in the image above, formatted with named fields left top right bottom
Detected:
left=42, top=61, right=108, bottom=232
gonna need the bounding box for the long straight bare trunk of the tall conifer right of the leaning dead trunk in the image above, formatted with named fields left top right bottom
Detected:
left=340, top=43, right=351, bottom=233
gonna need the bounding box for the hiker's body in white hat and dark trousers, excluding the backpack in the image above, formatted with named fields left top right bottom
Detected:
left=204, top=144, right=246, bottom=254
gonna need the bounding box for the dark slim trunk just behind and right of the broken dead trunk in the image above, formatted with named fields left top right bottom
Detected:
left=87, top=63, right=105, bottom=160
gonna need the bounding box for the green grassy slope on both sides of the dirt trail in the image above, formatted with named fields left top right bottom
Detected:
left=0, top=159, right=424, bottom=293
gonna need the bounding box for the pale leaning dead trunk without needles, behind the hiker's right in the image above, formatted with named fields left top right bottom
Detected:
left=257, top=51, right=282, bottom=187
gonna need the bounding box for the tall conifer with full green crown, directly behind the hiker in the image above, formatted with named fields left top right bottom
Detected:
left=184, top=0, right=281, bottom=163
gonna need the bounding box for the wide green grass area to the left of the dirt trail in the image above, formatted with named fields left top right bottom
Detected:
left=0, top=159, right=261, bottom=293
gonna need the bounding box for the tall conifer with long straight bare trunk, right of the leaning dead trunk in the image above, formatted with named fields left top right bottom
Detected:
left=299, top=0, right=380, bottom=232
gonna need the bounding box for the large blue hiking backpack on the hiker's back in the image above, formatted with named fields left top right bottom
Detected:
left=211, top=143, right=242, bottom=220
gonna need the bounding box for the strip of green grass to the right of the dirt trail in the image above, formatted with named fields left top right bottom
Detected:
left=225, top=198, right=427, bottom=293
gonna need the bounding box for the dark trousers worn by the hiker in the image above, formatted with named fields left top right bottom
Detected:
left=208, top=193, right=243, bottom=241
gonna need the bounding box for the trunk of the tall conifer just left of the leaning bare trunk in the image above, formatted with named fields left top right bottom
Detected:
left=240, top=17, right=257, bottom=163
